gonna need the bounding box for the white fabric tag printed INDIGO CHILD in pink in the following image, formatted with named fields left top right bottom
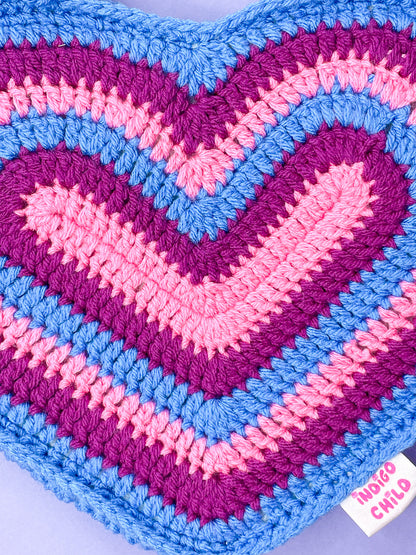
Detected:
left=341, top=453, right=416, bottom=537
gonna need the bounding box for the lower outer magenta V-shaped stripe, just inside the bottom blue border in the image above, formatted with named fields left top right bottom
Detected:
left=0, top=320, right=416, bottom=523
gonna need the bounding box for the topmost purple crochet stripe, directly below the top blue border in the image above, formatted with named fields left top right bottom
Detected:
left=0, top=21, right=416, bottom=154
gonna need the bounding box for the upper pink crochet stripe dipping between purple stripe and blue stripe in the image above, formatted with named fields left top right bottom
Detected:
left=0, top=51, right=416, bottom=198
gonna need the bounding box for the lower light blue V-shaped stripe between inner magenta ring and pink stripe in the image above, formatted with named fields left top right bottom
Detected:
left=0, top=222, right=416, bottom=445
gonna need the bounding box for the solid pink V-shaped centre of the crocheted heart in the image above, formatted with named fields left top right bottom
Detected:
left=17, top=163, right=375, bottom=356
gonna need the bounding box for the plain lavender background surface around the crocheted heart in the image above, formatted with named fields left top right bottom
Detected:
left=0, top=0, right=416, bottom=555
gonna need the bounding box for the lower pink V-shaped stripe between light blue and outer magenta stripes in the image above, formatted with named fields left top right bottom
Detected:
left=0, top=271, right=416, bottom=478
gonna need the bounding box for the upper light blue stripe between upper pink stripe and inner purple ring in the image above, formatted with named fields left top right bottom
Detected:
left=0, top=81, right=415, bottom=243
